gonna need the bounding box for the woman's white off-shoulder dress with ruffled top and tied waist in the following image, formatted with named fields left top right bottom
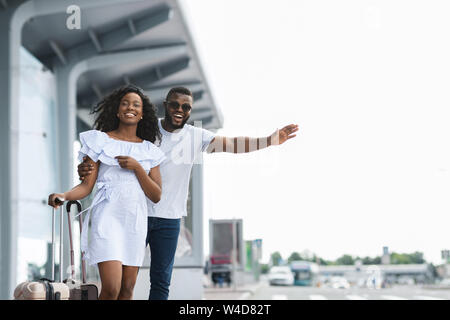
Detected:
left=78, top=130, right=165, bottom=266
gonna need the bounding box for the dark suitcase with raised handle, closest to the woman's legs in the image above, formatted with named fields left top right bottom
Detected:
left=63, top=200, right=98, bottom=300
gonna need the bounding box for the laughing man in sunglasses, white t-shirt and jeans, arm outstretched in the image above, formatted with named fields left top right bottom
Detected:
left=78, top=87, right=298, bottom=300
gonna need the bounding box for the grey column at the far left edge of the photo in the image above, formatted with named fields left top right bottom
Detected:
left=0, top=1, right=28, bottom=299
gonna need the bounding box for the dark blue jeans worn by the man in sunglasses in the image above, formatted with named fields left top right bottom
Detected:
left=147, top=217, right=181, bottom=300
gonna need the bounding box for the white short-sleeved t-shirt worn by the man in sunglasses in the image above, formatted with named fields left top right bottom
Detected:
left=147, top=119, right=215, bottom=219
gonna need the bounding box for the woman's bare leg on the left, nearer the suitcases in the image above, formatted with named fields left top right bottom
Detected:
left=98, top=260, right=122, bottom=300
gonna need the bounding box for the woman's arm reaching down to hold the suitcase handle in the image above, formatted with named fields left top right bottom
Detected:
left=48, top=157, right=99, bottom=208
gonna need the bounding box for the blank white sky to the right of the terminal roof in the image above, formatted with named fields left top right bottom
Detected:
left=185, top=0, right=450, bottom=263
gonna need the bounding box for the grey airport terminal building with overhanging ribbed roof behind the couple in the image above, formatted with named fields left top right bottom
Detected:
left=0, top=0, right=223, bottom=299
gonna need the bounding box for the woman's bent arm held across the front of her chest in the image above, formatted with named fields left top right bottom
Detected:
left=115, top=156, right=162, bottom=203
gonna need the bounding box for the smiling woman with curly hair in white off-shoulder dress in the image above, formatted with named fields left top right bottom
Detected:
left=48, top=85, right=165, bottom=299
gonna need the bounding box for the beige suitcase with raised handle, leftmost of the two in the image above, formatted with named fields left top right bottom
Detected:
left=14, top=202, right=70, bottom=300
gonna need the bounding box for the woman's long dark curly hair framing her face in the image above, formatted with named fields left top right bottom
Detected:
left=91, top=84, right=161, bottom=143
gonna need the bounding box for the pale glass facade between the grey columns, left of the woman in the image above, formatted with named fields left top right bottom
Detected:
left=16, top=48, right=58, bottom=282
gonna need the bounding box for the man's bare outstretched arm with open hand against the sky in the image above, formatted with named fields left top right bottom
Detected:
left=206, top=124, right=298, bottom=153
